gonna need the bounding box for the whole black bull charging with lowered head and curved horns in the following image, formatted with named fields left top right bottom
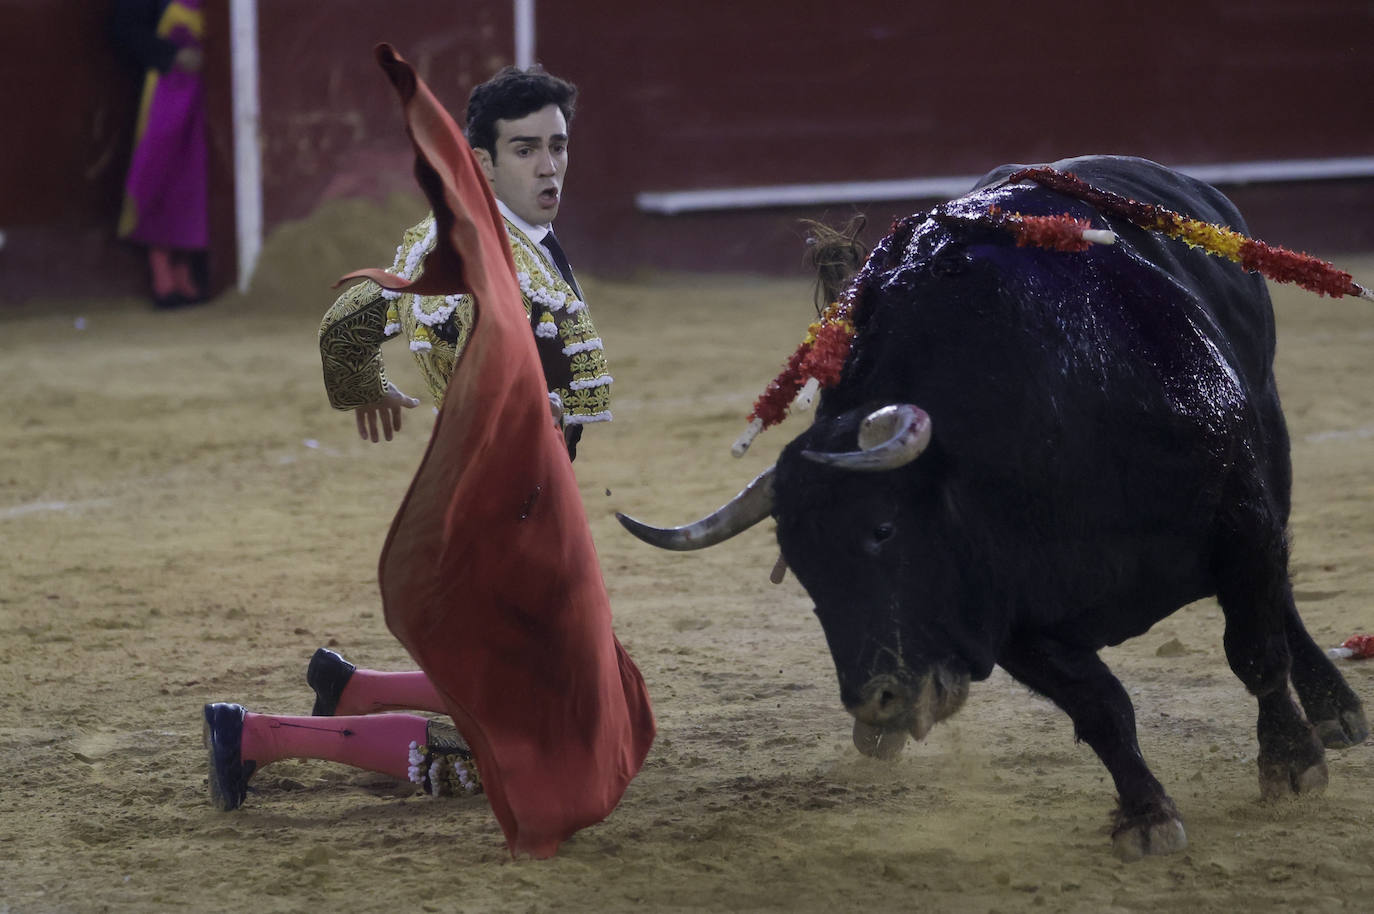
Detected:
left=621, top=157, right=1369, bottom=859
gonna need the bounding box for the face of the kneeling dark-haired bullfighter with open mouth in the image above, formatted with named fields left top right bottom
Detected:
left=475, top=104, right=567, bottom=225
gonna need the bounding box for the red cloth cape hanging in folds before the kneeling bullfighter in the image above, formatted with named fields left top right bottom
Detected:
left=335, top=44, right=654, bottom=858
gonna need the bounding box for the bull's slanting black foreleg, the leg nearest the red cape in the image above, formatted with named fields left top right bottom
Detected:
left=998, top=636, right=1189, bottom=860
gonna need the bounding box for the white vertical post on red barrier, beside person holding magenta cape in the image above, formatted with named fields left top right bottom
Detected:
left=229, top=0, right=262, bottom=293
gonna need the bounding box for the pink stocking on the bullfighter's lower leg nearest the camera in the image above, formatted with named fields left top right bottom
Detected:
left=240, top=712, right=429, bottom=781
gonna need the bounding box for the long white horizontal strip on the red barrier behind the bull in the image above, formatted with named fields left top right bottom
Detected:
left=635, top=157, right=1374, bottom=216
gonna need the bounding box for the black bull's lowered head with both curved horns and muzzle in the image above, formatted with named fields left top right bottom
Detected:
left=617, top=404, right=969, bottom=757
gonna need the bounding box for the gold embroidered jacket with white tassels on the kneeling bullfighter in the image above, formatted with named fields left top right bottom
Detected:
left=320, top=216, right=611, bottom=425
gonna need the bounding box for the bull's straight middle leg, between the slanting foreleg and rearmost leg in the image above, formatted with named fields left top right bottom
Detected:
left=1216, top=508, right=1327, bottom=797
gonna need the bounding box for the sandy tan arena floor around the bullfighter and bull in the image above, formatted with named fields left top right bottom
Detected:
left=0, top=199, right=1374, bottom=914
